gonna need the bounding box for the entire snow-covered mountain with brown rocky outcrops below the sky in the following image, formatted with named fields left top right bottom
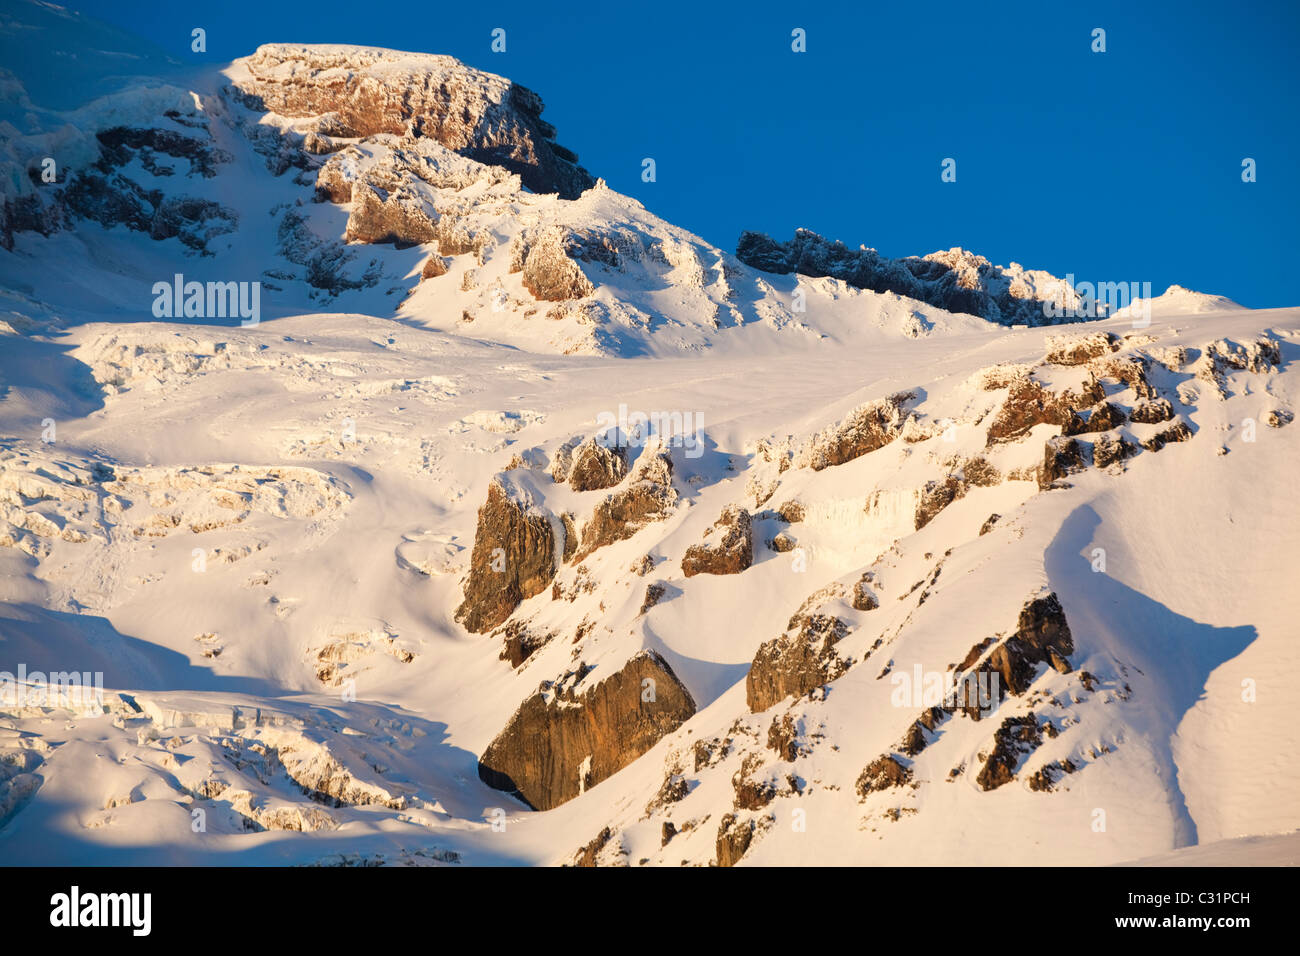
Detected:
left=0, top=4, right=1300, bottom=865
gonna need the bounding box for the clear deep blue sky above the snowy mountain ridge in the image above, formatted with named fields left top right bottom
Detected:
left=48, top=0, right=1300, bottom=307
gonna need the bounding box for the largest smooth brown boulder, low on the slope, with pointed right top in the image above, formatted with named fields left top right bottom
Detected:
left=478, top=650, right=696, bottom=810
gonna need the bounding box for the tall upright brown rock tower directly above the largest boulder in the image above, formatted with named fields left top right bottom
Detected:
left=456, top=481, right=556, bottom=633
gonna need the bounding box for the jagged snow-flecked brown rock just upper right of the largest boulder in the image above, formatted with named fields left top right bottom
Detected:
left=745, top=614, right=849, bottom=714
